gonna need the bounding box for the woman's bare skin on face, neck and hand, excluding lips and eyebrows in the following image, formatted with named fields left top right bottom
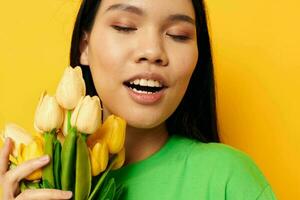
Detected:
left=0, top=0, right=198, bottom=200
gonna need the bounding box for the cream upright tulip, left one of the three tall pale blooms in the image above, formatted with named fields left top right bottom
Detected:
left=34, top=92, right=63, bottom=132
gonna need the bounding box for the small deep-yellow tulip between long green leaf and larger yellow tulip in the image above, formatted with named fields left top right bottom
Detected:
left=89, top=140, right=109, bottom=176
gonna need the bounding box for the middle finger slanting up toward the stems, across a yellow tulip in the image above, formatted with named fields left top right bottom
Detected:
left=7, top=155, right=50, bottom=182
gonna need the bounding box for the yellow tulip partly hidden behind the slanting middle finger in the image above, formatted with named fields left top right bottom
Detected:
left=17, top=137, right=44, bottom=181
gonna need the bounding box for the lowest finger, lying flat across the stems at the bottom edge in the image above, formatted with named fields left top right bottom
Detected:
left=16, top=189, right=72, bottom=200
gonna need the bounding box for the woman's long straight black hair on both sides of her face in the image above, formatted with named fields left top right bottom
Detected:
left=70, top=0, right=220, bottom=142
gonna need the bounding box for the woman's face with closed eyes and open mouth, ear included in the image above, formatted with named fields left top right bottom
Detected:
left=80, top=0, right=198, bottom=128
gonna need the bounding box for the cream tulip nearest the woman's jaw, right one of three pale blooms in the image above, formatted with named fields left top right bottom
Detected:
left=71, top=96, right=101, bottom=134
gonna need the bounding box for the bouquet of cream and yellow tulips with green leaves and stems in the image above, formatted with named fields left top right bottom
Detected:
left=0, top=67, right=126, bottom=200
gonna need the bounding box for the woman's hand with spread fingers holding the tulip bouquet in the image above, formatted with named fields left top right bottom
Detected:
left=0, top=138, right=72, bottom=200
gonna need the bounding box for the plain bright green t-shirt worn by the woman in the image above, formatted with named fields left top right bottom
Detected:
left=109, top=135, right=276, bottom=200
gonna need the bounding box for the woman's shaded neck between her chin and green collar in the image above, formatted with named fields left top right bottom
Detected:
left=124, top=123, right=168, bottom=165
